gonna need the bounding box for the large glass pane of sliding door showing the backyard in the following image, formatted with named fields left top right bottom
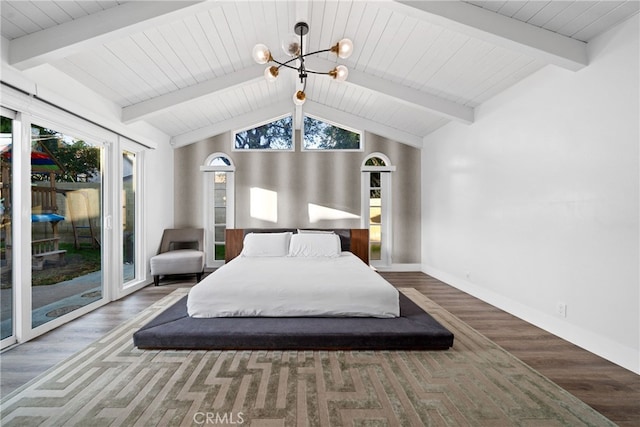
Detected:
left=31, top=123, right=104, bottom=328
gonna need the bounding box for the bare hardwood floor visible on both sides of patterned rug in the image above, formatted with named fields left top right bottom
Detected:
left=0, top=272, right=640, bottom=427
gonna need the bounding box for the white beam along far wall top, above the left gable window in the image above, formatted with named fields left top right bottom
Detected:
left=171, top=100, right=294, bottom=148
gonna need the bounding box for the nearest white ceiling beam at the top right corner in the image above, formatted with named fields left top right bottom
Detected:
left=385, top=1, right=589, bottom=71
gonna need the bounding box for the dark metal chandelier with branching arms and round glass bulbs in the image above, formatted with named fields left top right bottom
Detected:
left=253, top=22, right=353, bottom=105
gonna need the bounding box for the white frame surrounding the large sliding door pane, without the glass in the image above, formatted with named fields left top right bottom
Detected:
left=2, top=94, right=115, bottom=348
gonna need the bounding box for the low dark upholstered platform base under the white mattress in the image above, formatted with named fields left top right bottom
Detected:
left=133, top=294, right=453, bottom=350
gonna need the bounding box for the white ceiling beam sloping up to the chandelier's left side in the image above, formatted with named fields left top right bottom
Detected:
left=122, top=65, right=264, bottom=123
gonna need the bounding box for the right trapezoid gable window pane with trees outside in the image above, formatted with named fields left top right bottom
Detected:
left=304, top=116, right=360, bottom=150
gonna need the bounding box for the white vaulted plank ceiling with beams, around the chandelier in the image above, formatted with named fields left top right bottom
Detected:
left=0, top=0, right=640, bottom=147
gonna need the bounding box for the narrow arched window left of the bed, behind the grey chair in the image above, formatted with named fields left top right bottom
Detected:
left=200, top=153, right=236, bottom=267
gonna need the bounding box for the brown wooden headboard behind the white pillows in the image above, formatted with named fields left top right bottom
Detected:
left=224, top=228, right=369, bottom=265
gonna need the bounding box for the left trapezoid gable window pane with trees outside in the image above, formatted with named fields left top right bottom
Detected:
left=235, top=116, right=293, bottom=150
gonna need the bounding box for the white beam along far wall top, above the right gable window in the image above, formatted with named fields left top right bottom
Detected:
left=304, top=100, right=422, bottom=148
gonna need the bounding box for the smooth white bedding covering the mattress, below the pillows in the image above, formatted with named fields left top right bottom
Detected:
left=187, top=252, right=400, bottom=318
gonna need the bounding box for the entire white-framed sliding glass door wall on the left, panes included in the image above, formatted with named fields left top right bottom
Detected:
left=0, top=89, right=146, bottom=348
